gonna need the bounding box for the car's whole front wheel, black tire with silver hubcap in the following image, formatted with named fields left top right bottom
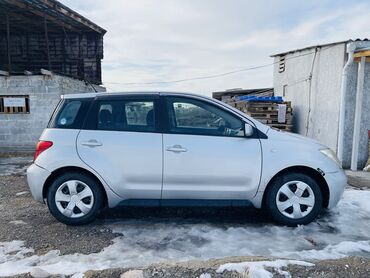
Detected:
left=266, top=173, right=323, bottom=226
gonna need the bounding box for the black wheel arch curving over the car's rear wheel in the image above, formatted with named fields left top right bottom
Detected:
left=42, top=166, right=108, bottom=206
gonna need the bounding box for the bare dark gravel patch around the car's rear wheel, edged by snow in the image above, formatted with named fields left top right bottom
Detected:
left=0, top=176, right=117, bottom=254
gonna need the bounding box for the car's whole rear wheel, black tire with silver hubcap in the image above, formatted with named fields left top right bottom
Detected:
left=47, top=173, right=103, bottom=225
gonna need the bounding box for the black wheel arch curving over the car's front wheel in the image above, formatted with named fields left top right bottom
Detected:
left=262, top=166, right=330, bottom=208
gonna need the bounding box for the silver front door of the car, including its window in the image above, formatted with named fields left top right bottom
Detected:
left=162, top=96, right=262, bottom=200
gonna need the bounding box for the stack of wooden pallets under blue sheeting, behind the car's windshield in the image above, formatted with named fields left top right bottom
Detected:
left=227, top=97, right=293, bottom=131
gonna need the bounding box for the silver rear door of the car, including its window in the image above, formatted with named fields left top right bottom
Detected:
left=77, top=95, right=162, bottom=199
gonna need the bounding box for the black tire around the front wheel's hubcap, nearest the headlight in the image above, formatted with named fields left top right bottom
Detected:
left=266, top=173, right=323, bottom=227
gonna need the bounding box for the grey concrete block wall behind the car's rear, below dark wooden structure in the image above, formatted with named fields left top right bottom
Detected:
left=0, top=75, right=105, bottom=152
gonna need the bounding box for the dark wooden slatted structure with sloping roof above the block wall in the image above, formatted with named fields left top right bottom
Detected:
left=0, top=0, right=106, bottom=84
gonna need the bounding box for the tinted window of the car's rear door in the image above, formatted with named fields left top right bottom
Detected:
left=96, top=100, right=156, bottom=132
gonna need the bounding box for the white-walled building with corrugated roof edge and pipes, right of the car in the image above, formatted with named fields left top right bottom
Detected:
left=272, top=40, right=370, bottom=170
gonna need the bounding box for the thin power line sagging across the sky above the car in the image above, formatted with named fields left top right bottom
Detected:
left=103, top=46, right=333, bottom=86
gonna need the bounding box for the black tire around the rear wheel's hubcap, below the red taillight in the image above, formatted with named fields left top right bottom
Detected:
left=47, top=172, right=104, bottom=226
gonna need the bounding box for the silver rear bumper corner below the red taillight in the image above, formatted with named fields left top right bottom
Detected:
left=27, top=163, right=50, bottom=203
